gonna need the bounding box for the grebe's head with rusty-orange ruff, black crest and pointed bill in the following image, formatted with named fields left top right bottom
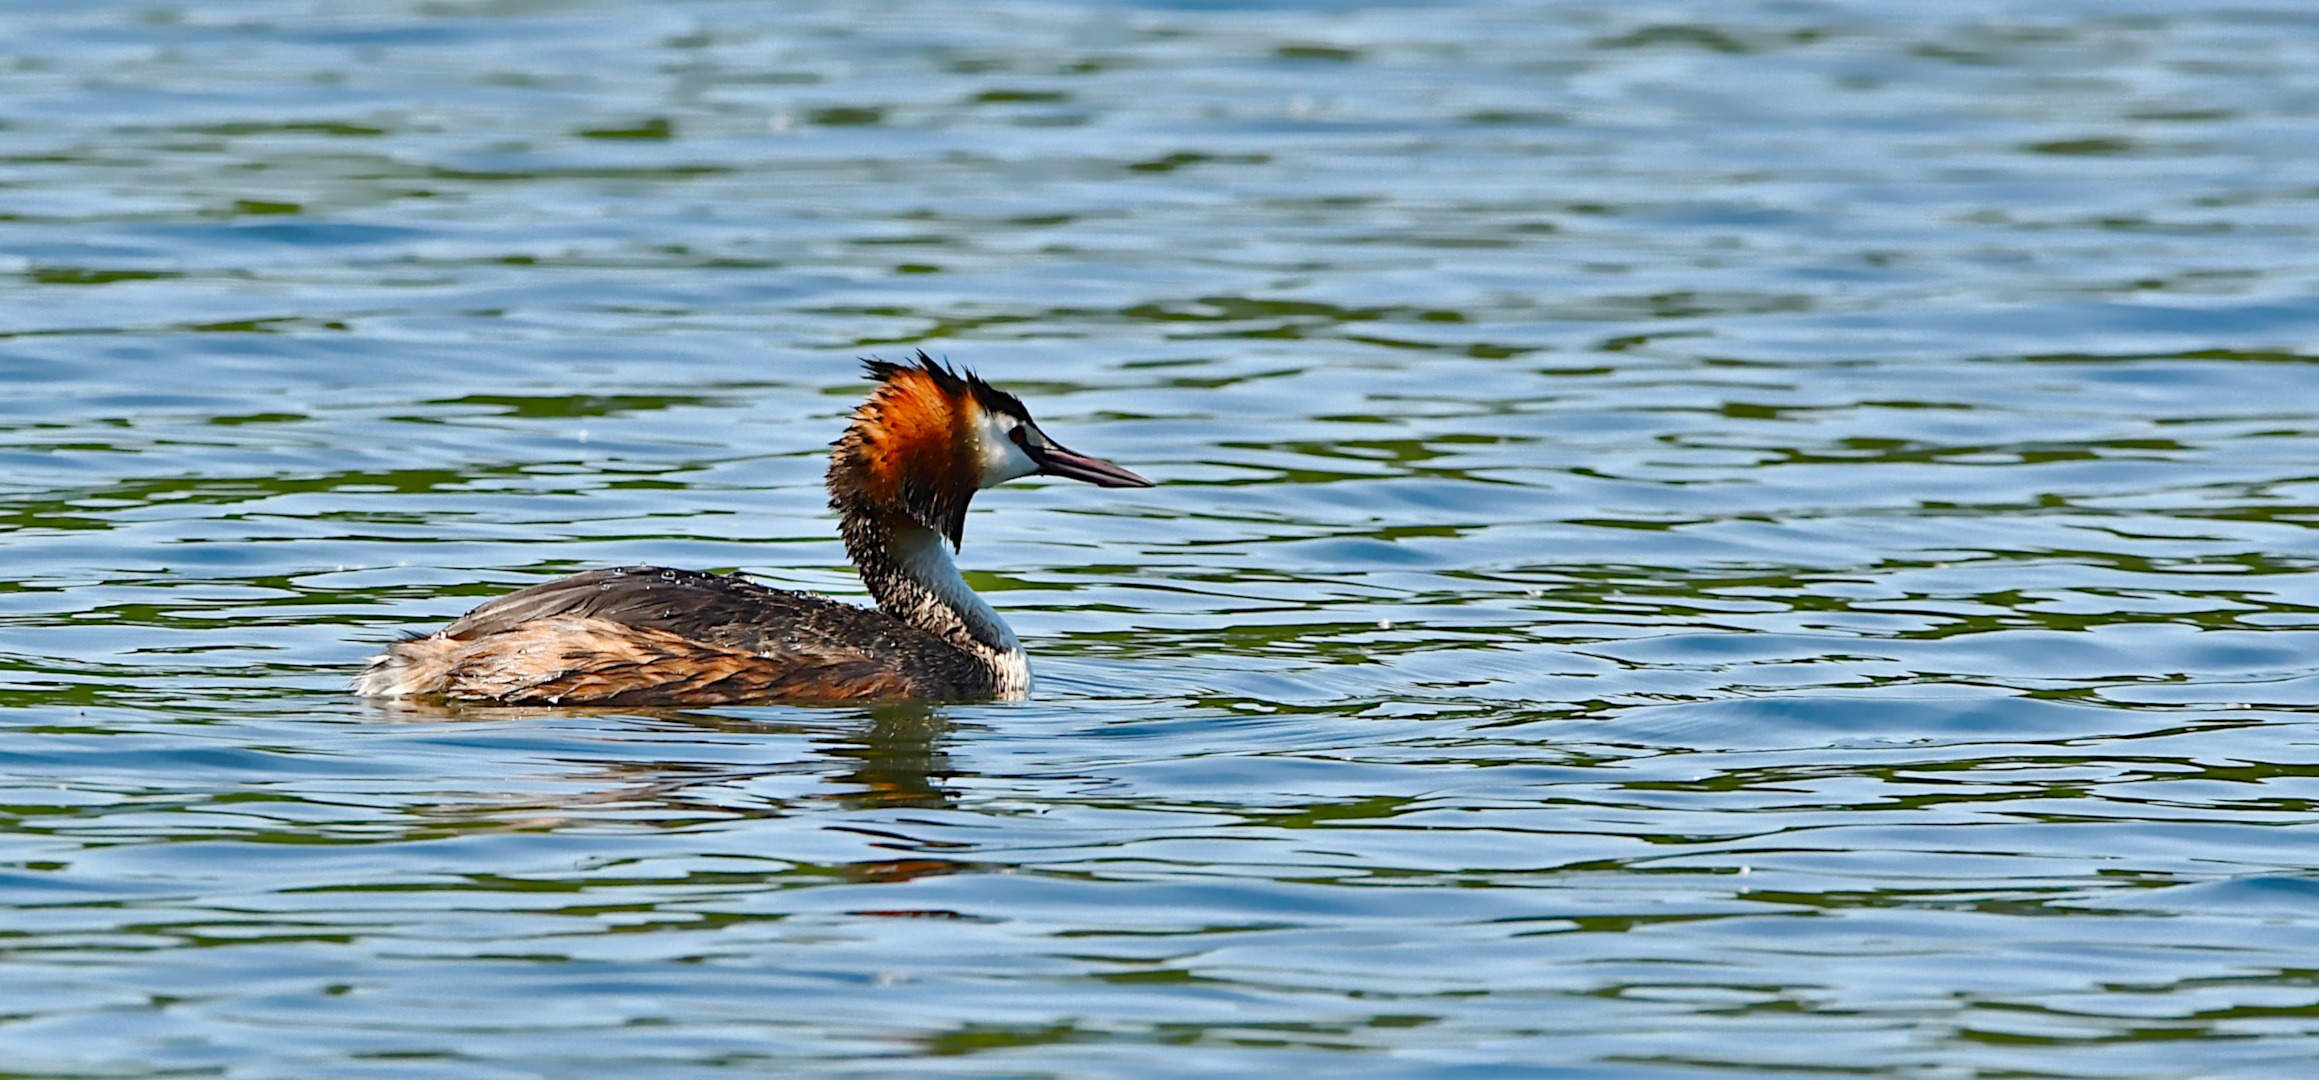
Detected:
left=828, top=350, right=1153, bottom=547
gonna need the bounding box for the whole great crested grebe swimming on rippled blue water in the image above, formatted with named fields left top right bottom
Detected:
left=355, top=352, right=1153, bottom=705
